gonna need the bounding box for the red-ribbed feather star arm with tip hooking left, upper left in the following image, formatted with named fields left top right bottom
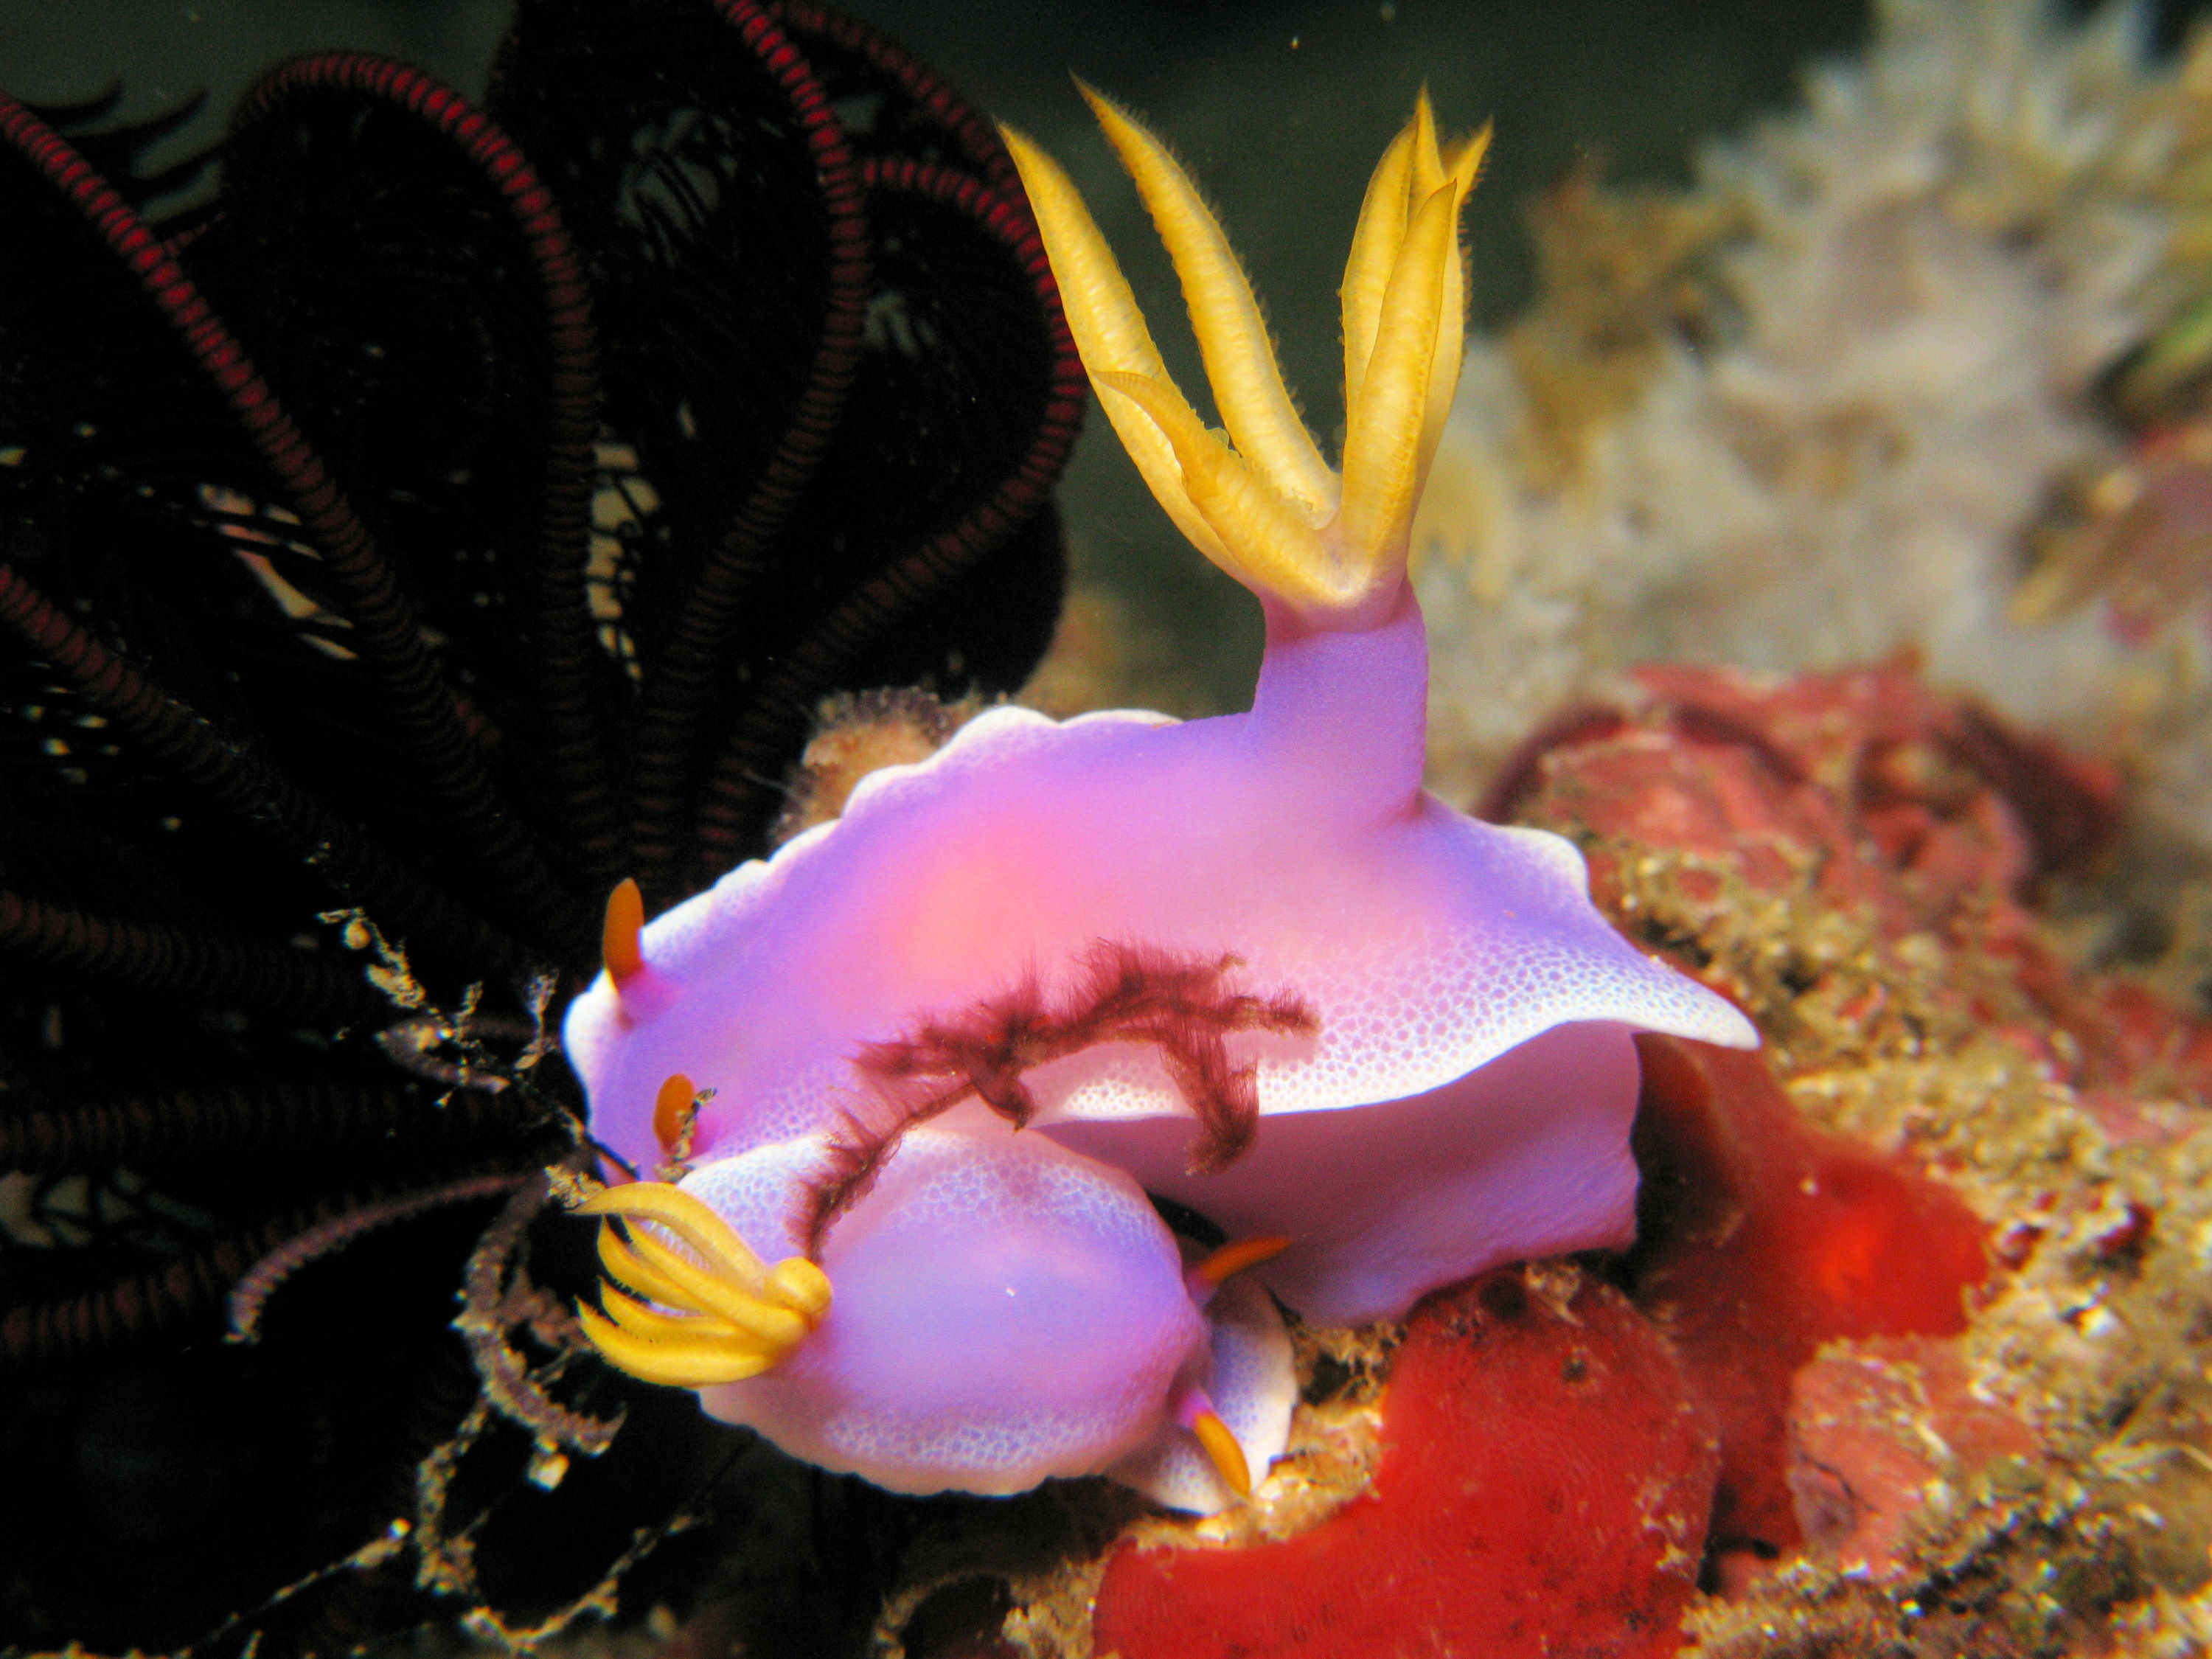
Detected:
left=239, top=51, right=630, bottom=889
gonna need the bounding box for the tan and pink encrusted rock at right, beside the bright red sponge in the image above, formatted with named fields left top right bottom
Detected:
left=1520, top=668, right=2212, bottom=1657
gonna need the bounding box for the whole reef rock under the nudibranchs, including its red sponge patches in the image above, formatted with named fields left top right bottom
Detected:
left=885, top=664, right=2212, bottom=1659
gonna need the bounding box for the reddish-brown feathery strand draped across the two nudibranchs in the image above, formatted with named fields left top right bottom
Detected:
left=803, top=940, right=1321, bottom=1261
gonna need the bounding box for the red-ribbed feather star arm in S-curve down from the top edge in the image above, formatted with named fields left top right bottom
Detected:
left=633, top=0, right=869, bottom=900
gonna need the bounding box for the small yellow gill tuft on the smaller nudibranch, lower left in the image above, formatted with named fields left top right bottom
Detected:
left=575, top=1181, right=830, bottom=1389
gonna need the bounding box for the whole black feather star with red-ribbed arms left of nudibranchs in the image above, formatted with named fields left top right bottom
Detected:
left=0, top=0, right=1082, bottom=1652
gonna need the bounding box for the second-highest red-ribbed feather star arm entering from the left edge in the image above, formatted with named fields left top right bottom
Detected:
left=0, top=564, right=531, bottom=978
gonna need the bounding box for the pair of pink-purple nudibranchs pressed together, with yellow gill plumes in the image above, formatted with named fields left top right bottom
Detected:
left=566, top=97, right=1756, bottom=1511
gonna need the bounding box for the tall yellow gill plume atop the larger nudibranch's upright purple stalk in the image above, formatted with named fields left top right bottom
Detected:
left=1002, top=86, right=1491, bottom=628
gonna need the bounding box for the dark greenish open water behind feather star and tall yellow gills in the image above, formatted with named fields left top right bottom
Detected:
left=0, top=0, right=2205, bottom=712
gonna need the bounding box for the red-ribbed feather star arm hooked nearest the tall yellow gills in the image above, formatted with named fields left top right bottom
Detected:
left=697, top=161, right=1088, bottom=880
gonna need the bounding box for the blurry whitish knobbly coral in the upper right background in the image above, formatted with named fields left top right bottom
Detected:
left=1420, top=0, right=2212, bottom=858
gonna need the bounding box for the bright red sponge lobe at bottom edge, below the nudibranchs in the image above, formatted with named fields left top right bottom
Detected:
left=1095, top=1270, right=1717, bottom=1659
